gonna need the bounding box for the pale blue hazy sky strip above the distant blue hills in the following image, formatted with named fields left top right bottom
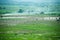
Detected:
left=0, top=0, right=60, bottom=2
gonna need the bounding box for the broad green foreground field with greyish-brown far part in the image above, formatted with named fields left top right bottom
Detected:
left=0, top=16, right=60, bottom=40
